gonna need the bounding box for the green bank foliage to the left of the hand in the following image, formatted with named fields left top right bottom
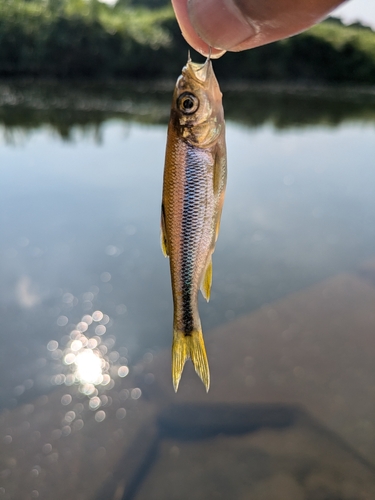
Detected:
left=0, top=0, right=182, bottom=77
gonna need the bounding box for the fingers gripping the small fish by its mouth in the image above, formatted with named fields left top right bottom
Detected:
left=172, top=0, right=350, bottom=59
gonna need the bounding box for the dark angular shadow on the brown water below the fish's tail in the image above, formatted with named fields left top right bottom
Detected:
left=95, top=404, right=375, bottom=500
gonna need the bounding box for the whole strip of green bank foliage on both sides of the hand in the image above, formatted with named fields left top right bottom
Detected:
left=0, top=0, right=375, bottom=84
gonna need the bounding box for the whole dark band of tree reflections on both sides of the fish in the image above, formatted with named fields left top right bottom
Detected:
left=0, top=82, right=375, bottom=143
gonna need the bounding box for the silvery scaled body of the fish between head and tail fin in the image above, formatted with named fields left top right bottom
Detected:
left=166, top=144, right=215, bottom=334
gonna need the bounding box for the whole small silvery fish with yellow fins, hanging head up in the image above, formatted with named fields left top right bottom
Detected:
left=161, top=55, right=227, bottom=391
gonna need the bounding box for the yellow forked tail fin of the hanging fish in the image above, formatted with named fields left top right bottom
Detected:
left=172, top=330, right=210, bottom=392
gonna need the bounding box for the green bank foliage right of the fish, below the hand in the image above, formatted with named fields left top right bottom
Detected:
left=215, top=19, right=375, bottom=84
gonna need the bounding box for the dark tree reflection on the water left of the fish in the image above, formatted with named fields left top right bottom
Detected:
left=0, top=82, right=173, bottom=143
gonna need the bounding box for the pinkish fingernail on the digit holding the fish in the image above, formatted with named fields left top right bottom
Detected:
left=188, top=0, right=256, bottom=50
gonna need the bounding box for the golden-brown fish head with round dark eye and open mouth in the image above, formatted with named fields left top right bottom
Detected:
left=172, top=57, right=224, bottom=148
